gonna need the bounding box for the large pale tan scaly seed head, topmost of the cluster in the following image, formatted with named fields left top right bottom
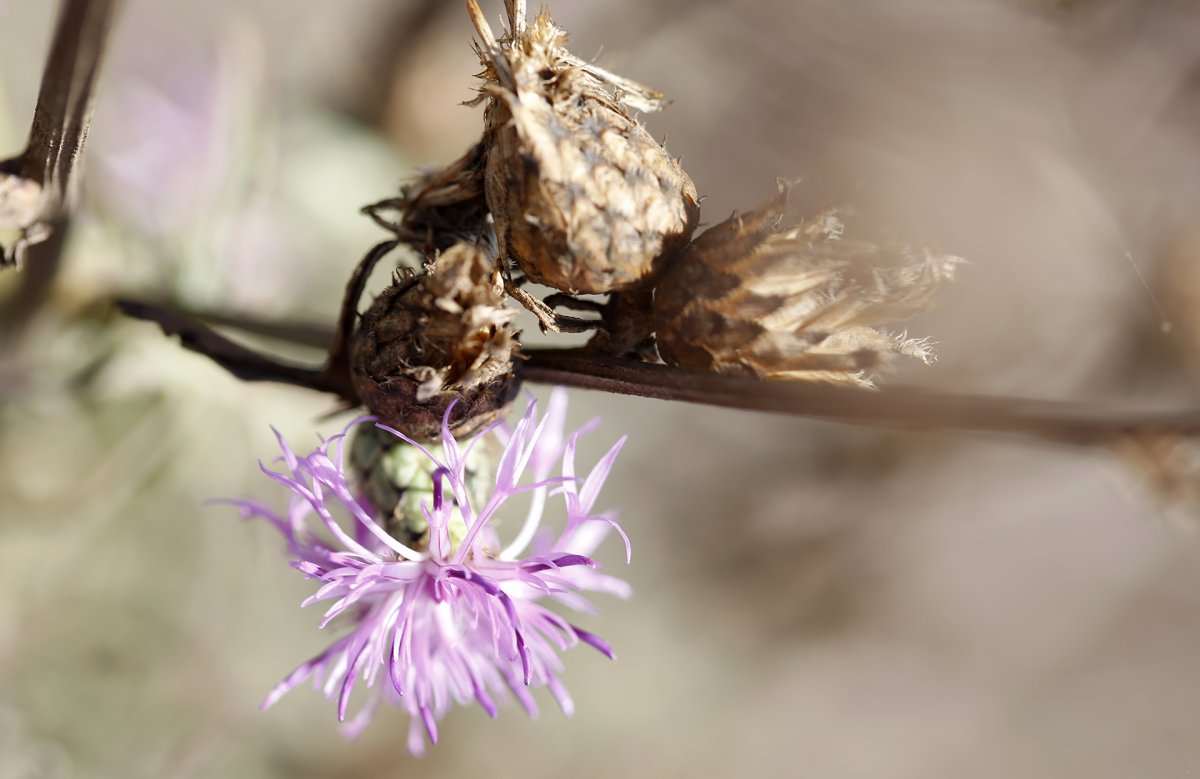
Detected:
left=467, top=0, right=700, bottom=293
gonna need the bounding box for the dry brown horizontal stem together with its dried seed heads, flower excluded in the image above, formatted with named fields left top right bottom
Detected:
left=122, top=0, right=1198, bottom=444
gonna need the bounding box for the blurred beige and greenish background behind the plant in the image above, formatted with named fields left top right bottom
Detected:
left=0, top=0, right=1200, bottom=779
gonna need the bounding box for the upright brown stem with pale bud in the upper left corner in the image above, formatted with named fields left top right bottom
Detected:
left=0, top=0, right=120, bottom=268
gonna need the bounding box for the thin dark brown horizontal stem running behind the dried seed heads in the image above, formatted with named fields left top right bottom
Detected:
left=118, top=295, right=1200, bottom=445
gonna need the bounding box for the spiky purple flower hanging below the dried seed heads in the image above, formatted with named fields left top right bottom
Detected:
left=228, top=389, right=630, bottom=755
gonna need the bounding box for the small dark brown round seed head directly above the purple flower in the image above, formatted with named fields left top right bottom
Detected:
left=350, top=244, right=517, bottom=439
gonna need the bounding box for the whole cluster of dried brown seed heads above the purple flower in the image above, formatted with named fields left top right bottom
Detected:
left=349, top=0, right=959, bottom=420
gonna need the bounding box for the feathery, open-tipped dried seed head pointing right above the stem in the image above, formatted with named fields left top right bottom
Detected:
left=654, top=188, right=961, bottom=386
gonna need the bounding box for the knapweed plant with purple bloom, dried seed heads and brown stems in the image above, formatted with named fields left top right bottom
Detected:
left=9, top=0, right=1200, bottom=753
